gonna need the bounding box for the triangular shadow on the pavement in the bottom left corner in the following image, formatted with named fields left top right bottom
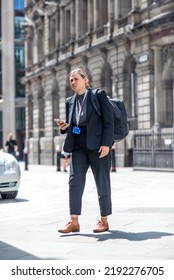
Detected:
left=0, top=241, right=41, bottom=260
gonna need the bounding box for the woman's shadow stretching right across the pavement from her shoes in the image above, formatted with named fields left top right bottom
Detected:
left=60, top=230, right=174, bottom=241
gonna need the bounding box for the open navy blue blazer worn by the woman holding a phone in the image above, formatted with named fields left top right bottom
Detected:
left=61, top=89, right=114, bottom=153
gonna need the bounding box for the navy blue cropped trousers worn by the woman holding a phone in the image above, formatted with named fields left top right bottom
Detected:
left=69, top=134, right=112, bottom=216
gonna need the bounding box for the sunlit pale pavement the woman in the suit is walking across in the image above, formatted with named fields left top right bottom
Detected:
left=0, top=163, right=174, bottom=260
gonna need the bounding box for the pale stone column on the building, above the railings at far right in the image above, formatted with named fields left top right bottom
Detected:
left=153, top=46, right=164, bottom=129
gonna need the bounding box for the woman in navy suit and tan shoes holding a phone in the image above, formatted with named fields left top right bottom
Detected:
left=55, top=68, right=114, bottom=233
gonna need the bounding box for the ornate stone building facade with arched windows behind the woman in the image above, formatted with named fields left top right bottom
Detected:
left=23, top=0, right=174, bottom=166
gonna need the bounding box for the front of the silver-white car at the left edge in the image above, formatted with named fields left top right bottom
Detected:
left=0, top=150, right=21, bottom=199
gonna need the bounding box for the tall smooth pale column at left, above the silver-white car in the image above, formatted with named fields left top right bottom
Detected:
left=1, top=0, right=16, bottom=145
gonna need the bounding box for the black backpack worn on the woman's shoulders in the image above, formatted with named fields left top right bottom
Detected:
left=91, top=89, right=129, bottom=142
